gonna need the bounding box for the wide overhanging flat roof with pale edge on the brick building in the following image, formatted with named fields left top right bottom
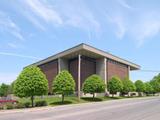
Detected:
left=32, top=43, right=140, bottom=70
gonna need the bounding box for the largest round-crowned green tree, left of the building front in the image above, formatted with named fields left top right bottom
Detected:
left=14, top=66, right=48, bottom=107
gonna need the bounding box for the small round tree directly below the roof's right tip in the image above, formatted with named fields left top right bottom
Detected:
left=135, top=80, right=145, bottom=96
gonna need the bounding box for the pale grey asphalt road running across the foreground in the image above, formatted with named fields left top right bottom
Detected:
left=0, top=97, right=160, bottom=120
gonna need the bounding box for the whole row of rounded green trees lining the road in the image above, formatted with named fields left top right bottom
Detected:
left=0, top=66, right=160, bottom=106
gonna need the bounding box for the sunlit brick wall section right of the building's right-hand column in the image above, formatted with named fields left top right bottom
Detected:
left=106, top=60, right=128, bottom=80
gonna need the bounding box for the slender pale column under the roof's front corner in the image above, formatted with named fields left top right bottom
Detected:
left=78, top=54, right=81, bottom=100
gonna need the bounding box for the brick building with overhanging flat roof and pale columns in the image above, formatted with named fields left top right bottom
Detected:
left=30, top=43, right=140, bottom=96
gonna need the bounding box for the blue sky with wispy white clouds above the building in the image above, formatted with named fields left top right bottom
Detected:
left=0, top=0, right=160, bottom=83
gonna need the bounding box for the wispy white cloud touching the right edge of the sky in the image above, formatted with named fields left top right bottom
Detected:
left=130, top=12, right=160, bottom=46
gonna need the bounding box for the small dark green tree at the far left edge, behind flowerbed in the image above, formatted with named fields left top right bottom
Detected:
left=0, top=83, right=9, bottom=97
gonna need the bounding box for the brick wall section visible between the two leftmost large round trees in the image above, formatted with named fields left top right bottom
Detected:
left=39, top=60, right=58, bottom=93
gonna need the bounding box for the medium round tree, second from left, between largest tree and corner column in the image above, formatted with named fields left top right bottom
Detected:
left=52, top=70, right=75, bottom=103
